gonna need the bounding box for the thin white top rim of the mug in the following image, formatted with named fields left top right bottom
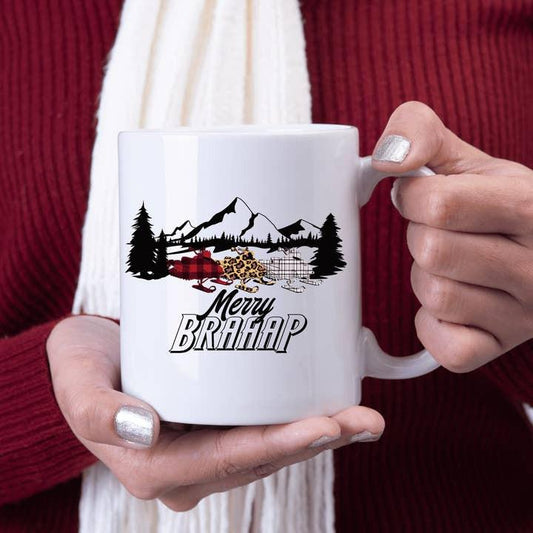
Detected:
left=118, top=123, right=357, bottom=137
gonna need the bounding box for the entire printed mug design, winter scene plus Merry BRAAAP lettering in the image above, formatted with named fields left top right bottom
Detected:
left=127, top=197, right=346, bottom=353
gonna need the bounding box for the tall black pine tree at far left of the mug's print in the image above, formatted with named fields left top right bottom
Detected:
left=126, top=202, right=156, bottom=279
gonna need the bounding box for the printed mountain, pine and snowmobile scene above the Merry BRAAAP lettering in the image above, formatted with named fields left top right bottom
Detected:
left=127, top=197, right=346, bottom=293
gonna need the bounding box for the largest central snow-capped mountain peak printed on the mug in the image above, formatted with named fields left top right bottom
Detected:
left=176, top=197, right=284, bottom=241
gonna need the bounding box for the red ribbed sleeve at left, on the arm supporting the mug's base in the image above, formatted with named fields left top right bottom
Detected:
left=0, top=320, right=96, bottom=505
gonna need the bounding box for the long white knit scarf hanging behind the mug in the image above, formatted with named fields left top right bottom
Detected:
left=73, top=0, right=334, bottom=533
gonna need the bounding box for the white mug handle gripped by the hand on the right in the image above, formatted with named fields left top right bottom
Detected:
left=358, top=156, right=440, bottom=379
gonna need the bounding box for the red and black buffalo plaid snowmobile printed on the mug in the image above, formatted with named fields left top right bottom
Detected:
left=167, top=250, right=232, bottom=292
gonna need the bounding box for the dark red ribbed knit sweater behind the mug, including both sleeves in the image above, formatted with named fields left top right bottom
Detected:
left=0, top=0, right=533, bottom=533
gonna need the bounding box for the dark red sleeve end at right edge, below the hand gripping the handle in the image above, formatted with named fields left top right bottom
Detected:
left=481, top=340, right=533, bottom=406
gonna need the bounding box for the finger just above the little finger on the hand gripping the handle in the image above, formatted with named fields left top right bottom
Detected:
left=411, top=263, right=533, bottom=340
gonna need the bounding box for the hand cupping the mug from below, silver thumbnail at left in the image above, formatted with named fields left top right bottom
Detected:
left=47, top=316, right=384, bottom=511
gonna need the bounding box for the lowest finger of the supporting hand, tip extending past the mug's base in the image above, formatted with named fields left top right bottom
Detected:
left=157, top=406, right=385, bottom=511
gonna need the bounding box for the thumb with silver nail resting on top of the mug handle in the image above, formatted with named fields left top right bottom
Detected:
left=372, top=102, right=495, bottom=175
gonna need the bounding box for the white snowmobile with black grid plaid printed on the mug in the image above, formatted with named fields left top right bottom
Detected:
left=261, top=248, right=322, bottom=293
